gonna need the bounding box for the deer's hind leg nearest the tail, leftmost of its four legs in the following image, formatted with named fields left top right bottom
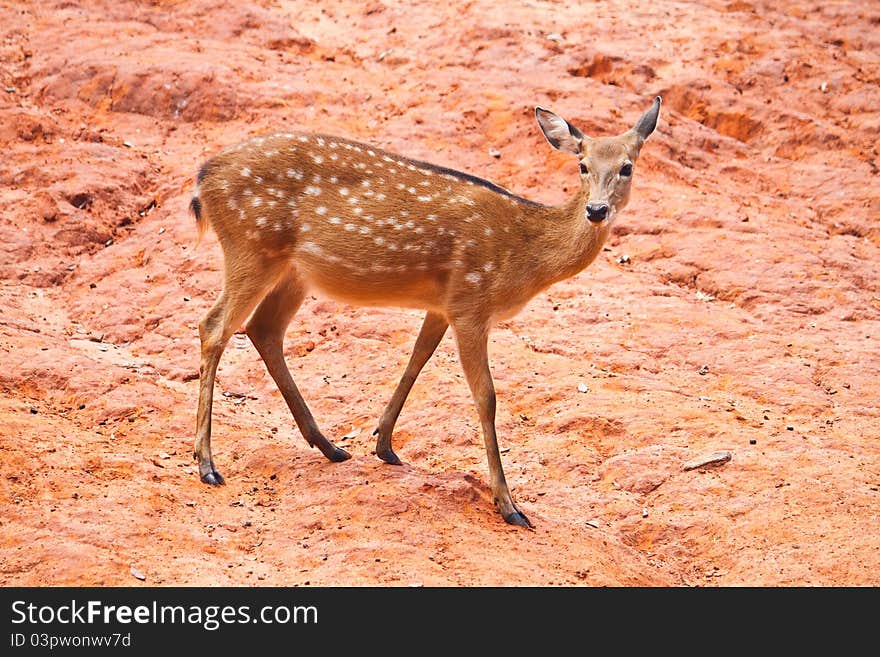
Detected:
left=193, top=259, right=288, bottom=486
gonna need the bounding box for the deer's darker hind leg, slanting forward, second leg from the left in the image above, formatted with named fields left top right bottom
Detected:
left=246, top=270, right=351, bottom=462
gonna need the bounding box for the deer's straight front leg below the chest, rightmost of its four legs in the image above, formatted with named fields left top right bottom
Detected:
left=453, top=322, right=532, bottom=528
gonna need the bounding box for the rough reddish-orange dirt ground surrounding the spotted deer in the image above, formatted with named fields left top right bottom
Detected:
left=0, top=0, right=880, bottom=587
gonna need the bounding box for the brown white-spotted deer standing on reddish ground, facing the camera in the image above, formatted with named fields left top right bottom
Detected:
left=190, top=96, right=661, bottom=528
